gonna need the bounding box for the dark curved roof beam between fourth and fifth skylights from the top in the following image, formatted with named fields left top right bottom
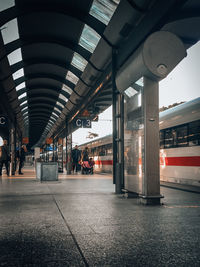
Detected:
left=15, top=73, right=82, bottom=97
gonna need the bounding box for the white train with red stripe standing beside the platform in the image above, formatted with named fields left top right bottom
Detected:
left=79, top=97, right=200, bottom=186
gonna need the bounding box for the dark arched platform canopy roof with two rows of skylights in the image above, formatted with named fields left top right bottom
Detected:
left=0, top=0, right=200, bottom=148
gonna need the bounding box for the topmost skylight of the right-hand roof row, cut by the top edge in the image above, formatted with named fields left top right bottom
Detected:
left=89, top=0, right=120, bottom=25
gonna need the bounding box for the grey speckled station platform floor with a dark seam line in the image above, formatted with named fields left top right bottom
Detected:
left=0, top=168, right=200, bottom=267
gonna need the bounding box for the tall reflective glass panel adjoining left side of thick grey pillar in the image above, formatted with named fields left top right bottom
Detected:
left=124, top=80, right=144, bottom=193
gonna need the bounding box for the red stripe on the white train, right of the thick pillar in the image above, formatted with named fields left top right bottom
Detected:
left=162, top=156, right=200, bottom=167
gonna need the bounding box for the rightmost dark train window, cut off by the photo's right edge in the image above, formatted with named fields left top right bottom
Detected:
left=189, top=120, right=200, bottom=146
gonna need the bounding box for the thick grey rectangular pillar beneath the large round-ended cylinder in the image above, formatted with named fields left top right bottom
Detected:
left=140, top=77, right=162, bottom=204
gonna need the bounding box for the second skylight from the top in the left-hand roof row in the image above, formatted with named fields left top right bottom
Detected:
left=1, top=18, right=19, bottom=45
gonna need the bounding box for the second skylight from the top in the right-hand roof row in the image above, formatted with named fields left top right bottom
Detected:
left=79, top=24, right=101, bottom=53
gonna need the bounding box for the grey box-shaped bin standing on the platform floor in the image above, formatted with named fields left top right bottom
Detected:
left=36, top=161, right=58, bottom=181
